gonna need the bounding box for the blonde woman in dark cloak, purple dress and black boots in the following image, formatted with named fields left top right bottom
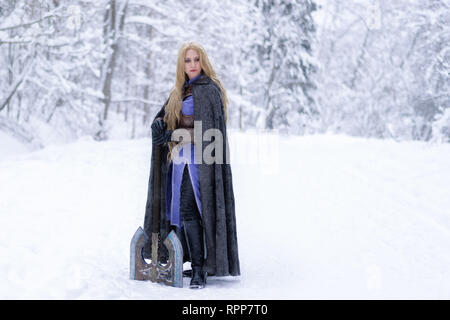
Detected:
left=143, top=42, right=240, bottom=288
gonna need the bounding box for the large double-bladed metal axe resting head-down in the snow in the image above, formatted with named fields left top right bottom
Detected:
left=130, top=145, right=183, bottom=288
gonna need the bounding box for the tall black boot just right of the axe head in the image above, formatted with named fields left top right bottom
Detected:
left=183, top=220, right=207, bottom=289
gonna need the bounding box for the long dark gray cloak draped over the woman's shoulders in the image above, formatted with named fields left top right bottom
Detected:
left=143, top=74, right=240, bottom=276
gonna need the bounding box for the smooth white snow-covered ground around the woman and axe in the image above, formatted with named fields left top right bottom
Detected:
left=0, top=132, right=450, bottom=299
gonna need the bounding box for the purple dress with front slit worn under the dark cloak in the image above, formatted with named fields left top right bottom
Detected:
left=166, top=75, right=202, bottom=228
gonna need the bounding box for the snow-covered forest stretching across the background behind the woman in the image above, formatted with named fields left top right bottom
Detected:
left=0, top=0, right=450, bottom=146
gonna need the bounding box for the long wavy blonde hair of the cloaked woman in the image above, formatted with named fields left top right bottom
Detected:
left=164, top=42, right=228, bottom=160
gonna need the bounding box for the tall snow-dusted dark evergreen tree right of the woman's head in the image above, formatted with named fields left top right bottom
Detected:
left=255, top=0, right=317, bottom=133
